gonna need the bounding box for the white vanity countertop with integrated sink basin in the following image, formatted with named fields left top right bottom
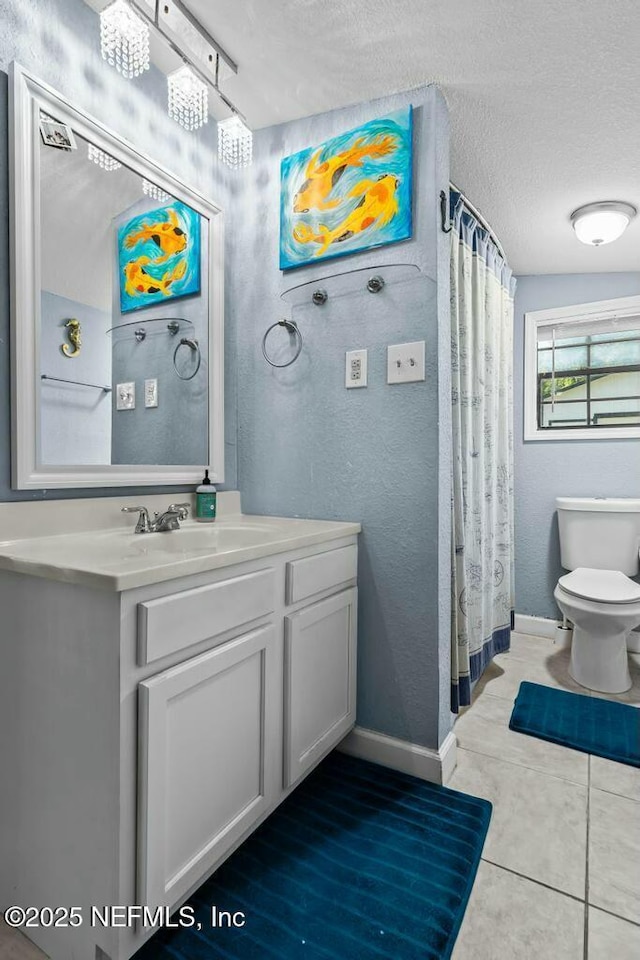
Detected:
left=0, top=516, right=360, bottom=591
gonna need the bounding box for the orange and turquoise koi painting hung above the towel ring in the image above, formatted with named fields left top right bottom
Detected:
left=280, top=107, right=412, bottom=270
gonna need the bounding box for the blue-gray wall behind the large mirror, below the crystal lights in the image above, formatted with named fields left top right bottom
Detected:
left=0, top=0, right=237, bottom=500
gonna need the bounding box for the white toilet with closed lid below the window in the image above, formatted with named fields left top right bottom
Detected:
left=554, top=497, right=640, bottom=693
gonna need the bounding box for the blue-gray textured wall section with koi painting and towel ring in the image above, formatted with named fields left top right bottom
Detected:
left=231, top=87, right=450, bottom=747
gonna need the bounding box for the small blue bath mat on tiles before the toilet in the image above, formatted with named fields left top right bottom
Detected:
left=509, top=681, right=640, bottom=767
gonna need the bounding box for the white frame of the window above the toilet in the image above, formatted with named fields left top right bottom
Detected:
left=524, top=297, right=640, bottom=441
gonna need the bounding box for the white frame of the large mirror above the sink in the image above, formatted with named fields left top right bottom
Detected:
left=9, top=62, right=224, bottom=490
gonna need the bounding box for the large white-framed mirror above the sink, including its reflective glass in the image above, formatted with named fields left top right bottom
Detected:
left=10, top=64, right=224, bottom=489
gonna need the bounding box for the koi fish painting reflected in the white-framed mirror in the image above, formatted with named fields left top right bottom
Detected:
left=118, top=201, right=200, bottom=313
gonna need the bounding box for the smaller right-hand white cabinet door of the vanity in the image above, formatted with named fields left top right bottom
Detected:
left=284, top=587, right=358, bottom=787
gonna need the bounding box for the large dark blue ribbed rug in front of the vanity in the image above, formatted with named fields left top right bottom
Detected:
left=135, top=753, right=491, bottom=960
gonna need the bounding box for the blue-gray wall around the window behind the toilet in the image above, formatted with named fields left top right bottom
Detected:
left=514, top=273, right=640, bottom=619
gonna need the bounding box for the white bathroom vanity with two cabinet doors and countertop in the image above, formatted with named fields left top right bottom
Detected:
left=0, top=501, right=360, bottom=960
